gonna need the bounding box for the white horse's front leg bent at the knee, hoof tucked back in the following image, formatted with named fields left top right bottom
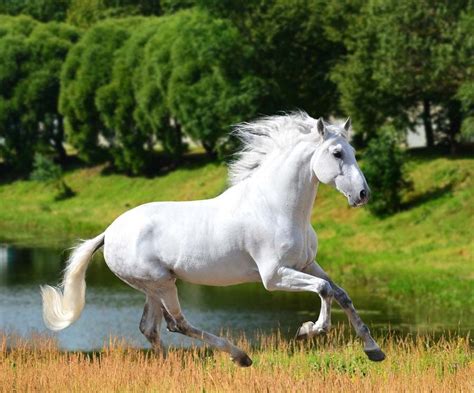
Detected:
left=260, top=266, right=334, bottom=339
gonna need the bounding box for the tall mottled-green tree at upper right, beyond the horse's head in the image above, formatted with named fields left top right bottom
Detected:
left=333, top=0, right=471, bottom=149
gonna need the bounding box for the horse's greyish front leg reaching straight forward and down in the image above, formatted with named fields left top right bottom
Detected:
left=305, top=262, right=385, bottom=361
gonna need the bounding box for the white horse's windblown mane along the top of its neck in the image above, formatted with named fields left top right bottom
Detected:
left=229, top=111, right=320, bottom=185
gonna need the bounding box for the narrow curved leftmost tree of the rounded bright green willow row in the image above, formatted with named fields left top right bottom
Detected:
left=59, top=18, right=143, bottom=161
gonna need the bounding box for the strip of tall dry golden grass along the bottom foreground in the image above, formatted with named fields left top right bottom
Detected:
left=0, top=330, right=474, bottom=392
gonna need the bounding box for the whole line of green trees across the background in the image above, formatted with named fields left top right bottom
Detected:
left=0, top=0, right=474, bottom=174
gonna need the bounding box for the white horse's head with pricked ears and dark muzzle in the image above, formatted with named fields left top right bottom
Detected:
left=311, top=118, right=370, bottom=207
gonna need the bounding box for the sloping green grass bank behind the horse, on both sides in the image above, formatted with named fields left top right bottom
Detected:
left=0, top=152, right=474, bottom=324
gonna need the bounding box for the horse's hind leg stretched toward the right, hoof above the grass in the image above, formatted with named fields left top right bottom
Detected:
left=160, top=282, right=252, bottom=367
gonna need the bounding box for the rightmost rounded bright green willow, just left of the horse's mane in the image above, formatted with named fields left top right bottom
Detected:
left=167, top=10, right=263, bottom=155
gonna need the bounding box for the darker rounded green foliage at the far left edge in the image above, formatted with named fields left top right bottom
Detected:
left=0, top=16, right=79, bottom=170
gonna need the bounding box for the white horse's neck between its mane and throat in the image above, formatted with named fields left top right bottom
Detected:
left=255, top=145, right=318, bottom=225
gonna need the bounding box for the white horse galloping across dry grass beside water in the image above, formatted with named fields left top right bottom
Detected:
left=42, top=112, right=385, bottom=366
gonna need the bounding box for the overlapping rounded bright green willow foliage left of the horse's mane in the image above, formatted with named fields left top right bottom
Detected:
left=60, top=9, right=262, bottom=170
